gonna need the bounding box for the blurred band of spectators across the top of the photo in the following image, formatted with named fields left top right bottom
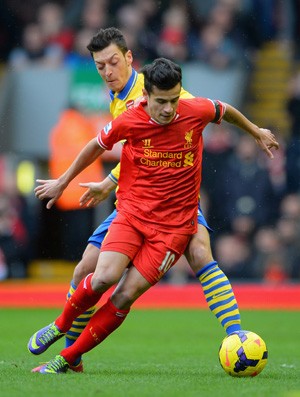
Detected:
left=0, top=0, right=300, bottom=68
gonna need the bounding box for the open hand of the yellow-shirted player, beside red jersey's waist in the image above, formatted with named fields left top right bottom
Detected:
left=79, top=178, right=116, bottom=207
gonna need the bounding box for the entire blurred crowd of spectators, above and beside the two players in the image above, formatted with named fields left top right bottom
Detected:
left=0, top=0, right=300, bottom=283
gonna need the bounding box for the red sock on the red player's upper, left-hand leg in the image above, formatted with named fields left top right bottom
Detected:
left=55, top=273, right=102, bottom=332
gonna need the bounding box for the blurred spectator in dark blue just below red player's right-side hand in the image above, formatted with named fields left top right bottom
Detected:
left=216, top=135, right=276, bottom=237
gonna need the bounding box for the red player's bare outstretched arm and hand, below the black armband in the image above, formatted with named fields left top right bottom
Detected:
left=223, top=103, right=279, bottom=158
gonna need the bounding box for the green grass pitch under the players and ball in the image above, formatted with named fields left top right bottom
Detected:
left=0, top=309, right=300, bottom=397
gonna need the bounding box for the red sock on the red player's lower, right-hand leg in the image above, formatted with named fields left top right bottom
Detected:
left=60, top=299, right=129, bottom=364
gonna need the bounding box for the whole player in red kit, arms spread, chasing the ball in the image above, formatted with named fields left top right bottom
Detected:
left=28, top=58, right=278, bottom=374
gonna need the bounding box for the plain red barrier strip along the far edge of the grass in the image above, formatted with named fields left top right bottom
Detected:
left=0, top=281, right=300, bottom=310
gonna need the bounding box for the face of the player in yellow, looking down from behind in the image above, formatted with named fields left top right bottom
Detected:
left=93, top=44, right=132, bottom=92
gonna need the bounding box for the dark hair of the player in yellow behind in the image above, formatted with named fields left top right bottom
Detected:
left=87, top=27, right=128, bottom=56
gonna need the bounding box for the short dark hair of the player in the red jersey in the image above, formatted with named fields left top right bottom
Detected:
left=141, top=58, right=182, bottom=94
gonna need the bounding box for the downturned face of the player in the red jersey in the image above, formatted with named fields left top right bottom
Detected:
left=144, top=83, right=181, bottom=124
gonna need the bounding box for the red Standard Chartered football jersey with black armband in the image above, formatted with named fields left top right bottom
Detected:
left=98, top=98, right=225, bottom=234
